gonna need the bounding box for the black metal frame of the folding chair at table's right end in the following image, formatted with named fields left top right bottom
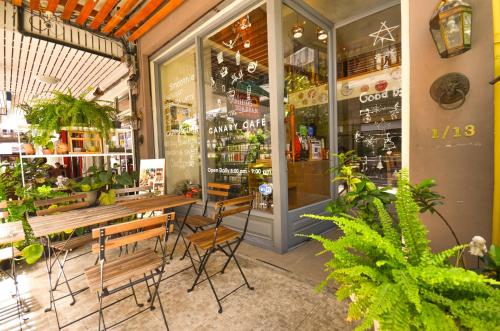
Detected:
left=187, top=196, right=254, bottom=313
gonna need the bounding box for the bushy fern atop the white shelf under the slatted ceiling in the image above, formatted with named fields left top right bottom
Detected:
left=21, top=91, right=116, bottom=147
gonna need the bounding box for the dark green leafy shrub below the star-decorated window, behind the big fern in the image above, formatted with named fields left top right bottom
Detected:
left=326, top=151, right=394, bottom=228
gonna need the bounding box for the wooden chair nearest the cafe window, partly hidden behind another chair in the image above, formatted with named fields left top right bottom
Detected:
left=181, top=183, right=231, bottom=260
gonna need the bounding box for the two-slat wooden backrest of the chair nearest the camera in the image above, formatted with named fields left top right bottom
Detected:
left=92, top=212, right=175, bottom=260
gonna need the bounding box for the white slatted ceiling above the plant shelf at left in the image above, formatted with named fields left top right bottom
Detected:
left=0, top=25, right=127, bottom=105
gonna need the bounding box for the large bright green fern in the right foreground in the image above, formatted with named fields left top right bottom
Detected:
left=306, top=171, right=500, bottom=330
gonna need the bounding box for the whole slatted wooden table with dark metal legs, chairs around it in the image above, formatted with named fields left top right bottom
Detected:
left=28, top=195, right=197, bottom=330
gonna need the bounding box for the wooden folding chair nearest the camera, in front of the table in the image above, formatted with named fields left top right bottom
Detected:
left=85, top=213, right=175, bottom=330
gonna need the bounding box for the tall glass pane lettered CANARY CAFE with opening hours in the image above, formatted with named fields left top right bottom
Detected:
left=203, top=5, right=273, bottom=212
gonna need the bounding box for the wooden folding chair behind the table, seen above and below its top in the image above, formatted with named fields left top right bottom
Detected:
left=34, top=193, right=92, bottom=305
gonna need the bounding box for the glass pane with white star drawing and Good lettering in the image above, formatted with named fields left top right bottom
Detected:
left=337, top=6, right=402, bottom=185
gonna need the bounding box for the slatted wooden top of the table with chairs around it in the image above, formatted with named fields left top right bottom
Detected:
left=28, top=195, right=197, bottom=237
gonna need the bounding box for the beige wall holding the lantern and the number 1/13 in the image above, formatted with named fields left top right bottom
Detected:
left=409, top=0, right=493, bottom=263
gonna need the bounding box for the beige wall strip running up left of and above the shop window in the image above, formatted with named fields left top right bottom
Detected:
left=137, top=0, right=221, bottom=159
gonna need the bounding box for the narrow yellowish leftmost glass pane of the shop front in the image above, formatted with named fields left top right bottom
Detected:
left=160, top=47, right=201, bottom=197
